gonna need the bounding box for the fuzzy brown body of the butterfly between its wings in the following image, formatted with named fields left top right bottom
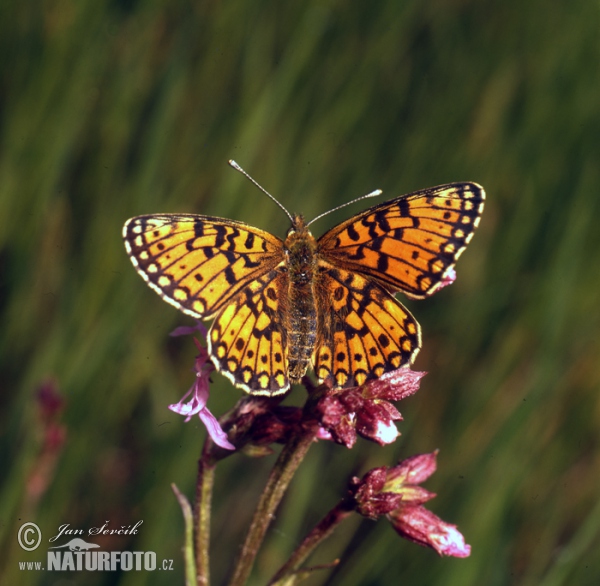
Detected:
left=284, top=216, right=317, bottom=382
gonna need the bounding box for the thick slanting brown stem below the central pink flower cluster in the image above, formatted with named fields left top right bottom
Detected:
left=229, top=431, right=315, bottom=586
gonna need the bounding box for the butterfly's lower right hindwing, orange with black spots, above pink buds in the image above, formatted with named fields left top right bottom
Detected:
left=312, top=263, right=421, bottom=388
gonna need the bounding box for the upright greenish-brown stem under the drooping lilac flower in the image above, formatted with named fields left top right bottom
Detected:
left=194, top=439, right=215, bottom=586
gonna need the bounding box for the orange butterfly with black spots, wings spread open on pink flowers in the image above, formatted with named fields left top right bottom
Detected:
left=123, top=161, right=485, bottom=396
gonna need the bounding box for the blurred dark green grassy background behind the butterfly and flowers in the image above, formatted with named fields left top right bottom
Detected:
left=0, top=0, right=600, bottom=586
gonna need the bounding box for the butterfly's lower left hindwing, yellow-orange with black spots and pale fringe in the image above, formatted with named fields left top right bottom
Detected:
left=208, top=268, right=290, bottom=395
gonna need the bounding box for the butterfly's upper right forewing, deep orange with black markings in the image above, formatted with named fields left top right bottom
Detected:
left=318, top=183, right=485, bottom=299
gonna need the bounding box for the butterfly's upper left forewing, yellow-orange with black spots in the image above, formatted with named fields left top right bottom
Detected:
left=123, top=214, right=283, bottom=319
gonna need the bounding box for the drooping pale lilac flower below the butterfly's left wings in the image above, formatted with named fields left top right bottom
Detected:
left=169, top=336, right=235, bottom=450
